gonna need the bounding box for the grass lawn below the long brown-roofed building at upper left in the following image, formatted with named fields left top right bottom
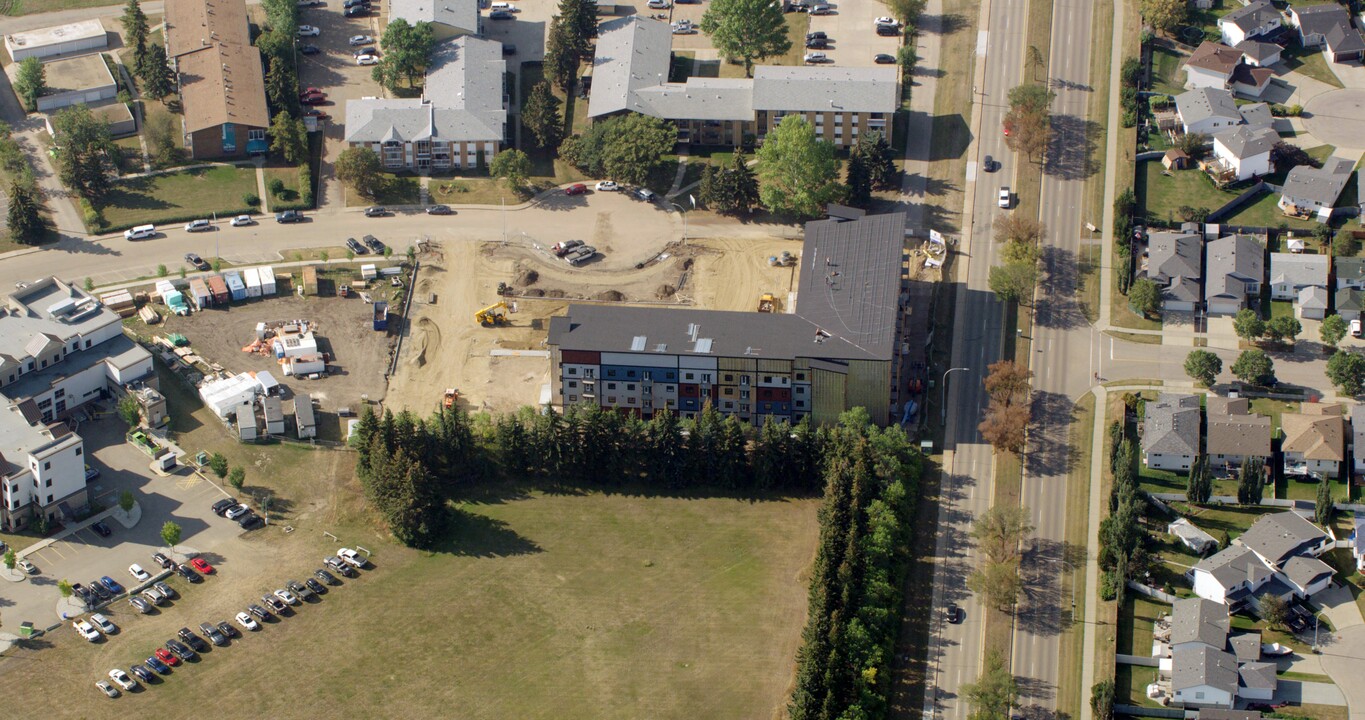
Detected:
left=100, top=165, right=257, bottom=232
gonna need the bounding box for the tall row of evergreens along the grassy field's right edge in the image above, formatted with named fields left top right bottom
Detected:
left=789, top=410, right=920, bottom=720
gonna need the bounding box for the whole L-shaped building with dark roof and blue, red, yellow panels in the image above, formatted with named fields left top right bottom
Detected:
left=549, top=213, right=905, bottom=422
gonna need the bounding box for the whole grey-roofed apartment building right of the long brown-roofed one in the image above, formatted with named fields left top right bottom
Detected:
left=345, top=36, right=508, bottom=172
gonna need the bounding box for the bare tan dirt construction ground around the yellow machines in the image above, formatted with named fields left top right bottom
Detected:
left=384, top=239, right=800, bottom=414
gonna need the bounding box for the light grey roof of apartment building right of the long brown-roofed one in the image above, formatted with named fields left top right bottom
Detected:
left=345, top=36, right=506, bottom=142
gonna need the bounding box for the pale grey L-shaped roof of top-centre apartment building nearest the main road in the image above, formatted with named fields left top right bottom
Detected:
left=588, top=15, right=898, bottom=120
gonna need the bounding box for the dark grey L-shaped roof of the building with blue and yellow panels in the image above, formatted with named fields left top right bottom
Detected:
left=550, top=213, right=905, bottom=361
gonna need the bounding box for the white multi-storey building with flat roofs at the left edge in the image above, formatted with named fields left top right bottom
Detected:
left=0, top=277, right=154, bottom=529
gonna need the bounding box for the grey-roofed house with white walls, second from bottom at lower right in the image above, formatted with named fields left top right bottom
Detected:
left=1188, top=512, right=1334, bottom=612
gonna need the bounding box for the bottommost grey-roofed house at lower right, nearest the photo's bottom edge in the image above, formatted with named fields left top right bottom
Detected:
left=1153, top=597, right=1276, bottom=717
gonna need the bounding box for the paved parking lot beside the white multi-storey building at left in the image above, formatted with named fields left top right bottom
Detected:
left=0, top=417, right=243, bottom=627
